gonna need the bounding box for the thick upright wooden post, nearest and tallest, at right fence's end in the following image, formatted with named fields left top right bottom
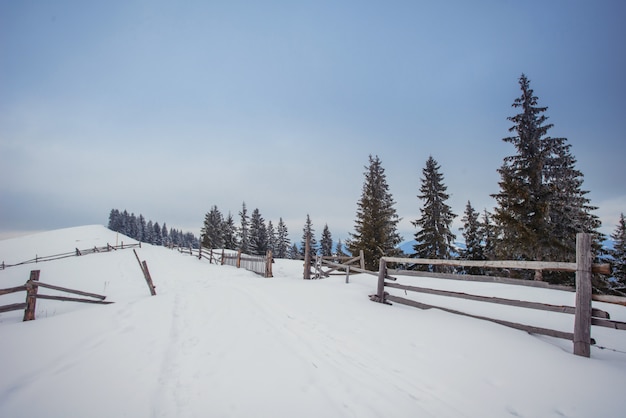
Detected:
left=574, top=233, right=593, bottom=357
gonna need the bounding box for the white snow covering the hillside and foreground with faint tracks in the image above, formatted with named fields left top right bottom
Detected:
left=0, top=226, right=626, bottom=418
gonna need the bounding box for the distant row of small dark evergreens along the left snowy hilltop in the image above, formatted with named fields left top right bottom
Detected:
left=108, top=209, right=199, bottom=248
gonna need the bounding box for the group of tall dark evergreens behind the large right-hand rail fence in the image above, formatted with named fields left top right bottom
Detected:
left=347, top=74, right=626, bottom=291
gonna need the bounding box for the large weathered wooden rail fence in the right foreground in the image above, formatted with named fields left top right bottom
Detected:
left=370, top=234, right=626, bottom=357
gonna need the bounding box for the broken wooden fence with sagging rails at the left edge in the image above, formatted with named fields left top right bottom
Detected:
left=0, top=270, right=113, bottom=321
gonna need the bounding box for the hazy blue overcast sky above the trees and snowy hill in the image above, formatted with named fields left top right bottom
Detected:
left=0, top=0, right=626, bottom=245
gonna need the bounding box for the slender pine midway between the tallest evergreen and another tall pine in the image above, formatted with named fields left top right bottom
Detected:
left=412, top=156, right=456, bottom=270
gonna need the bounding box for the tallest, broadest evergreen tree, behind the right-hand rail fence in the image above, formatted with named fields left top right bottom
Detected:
left=492, top=74, right=601, bottom=282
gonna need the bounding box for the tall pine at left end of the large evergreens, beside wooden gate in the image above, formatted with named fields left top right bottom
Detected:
left=347, top=155, right=402, bottom=270
